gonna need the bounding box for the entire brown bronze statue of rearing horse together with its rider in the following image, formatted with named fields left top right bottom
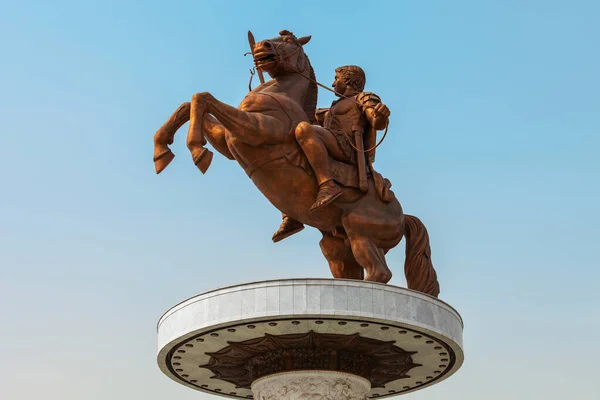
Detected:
left=154, top=31, right=439, bottom=297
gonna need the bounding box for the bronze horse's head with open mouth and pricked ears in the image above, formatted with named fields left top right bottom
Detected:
left=253, top=31, right=310, bottom=78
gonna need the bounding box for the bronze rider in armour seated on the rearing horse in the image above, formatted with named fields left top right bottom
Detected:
left=273, top=65, right=390, bottom=242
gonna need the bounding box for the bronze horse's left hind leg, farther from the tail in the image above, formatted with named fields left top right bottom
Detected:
left=319, top=232, right=364, bottom=280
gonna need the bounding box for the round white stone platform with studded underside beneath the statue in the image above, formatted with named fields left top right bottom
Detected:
left=158, top=279, right=463, bottom=398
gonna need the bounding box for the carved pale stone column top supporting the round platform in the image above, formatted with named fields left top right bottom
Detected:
left=252, top=371, right=371, bottom=400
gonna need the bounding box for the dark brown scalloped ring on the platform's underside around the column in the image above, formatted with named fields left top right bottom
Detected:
left=200, top=331, right=420, bottom=388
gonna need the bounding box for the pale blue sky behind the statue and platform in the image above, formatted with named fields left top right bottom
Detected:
left=0, top=0, right=600, bottom=400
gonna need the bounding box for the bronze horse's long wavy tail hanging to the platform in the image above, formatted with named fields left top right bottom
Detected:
left=404, top=215, right=440, bottom=297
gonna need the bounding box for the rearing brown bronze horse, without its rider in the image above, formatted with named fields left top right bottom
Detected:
left=154, top=31, right=439, bottom=297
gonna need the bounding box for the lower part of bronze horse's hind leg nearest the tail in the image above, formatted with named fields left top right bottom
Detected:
left=350, top=236, right=392, bottom=283
